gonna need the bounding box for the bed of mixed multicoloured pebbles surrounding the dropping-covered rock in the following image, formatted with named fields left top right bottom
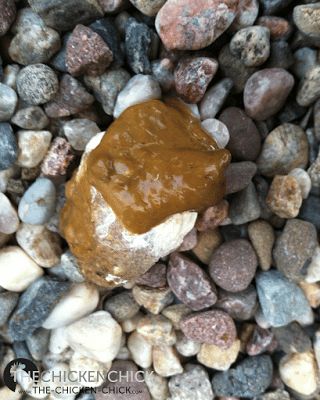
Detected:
left=0, top=0, right=320, bottom=400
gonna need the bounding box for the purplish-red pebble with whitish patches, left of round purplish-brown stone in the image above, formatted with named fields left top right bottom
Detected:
left=167, top=253, right=217, bottom=311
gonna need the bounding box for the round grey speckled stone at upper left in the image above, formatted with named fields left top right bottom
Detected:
left=17, top=64, right=59, bottom=105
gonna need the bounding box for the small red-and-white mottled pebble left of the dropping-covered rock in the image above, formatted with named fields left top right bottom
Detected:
left=41, top=137, right=74, bottom=177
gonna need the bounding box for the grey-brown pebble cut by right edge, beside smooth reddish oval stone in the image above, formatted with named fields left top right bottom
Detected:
left=296, top=65, right=320, bottom=107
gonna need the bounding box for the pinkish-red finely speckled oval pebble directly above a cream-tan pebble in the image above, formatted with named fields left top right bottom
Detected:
left=180, top=310, right=237, bottom=349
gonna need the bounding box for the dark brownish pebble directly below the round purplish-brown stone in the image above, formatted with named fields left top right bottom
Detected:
left=215, top=285, right=257, bottom=321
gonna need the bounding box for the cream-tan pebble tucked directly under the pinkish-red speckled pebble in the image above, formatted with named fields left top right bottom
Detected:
left=197, top=339, right=240, bottom=371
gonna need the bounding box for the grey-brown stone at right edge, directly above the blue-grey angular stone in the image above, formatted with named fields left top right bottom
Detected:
left=273, top=219, right=318, bottom=282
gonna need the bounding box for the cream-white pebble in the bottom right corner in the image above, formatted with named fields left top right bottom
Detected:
left=279, top=351, right=319, bottom=396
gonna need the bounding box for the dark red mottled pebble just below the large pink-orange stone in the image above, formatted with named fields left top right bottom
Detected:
left=174, top=57, right=218, bottom=103
